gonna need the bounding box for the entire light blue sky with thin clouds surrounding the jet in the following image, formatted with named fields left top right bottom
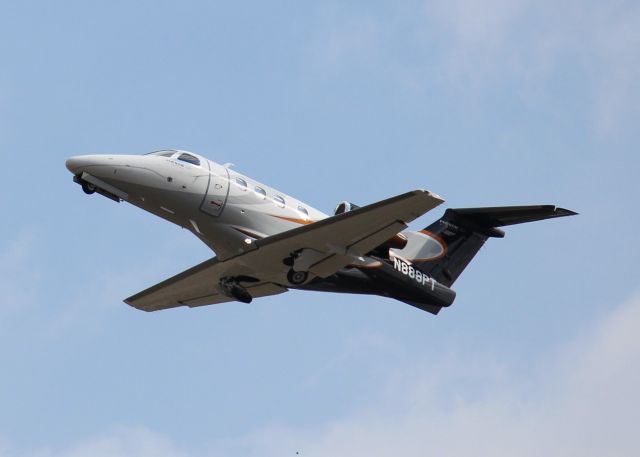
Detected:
left=0, top=0, right=640, bottom=457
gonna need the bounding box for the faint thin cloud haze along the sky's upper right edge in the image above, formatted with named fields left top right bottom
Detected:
left=311, top=0, right=640, bottom=135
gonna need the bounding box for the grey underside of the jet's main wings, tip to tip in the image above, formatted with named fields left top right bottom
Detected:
left=125, top=190, right=443, bottom=311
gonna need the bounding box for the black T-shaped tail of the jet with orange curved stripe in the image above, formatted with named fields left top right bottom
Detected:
left=397, top=205, right=577, bottom=287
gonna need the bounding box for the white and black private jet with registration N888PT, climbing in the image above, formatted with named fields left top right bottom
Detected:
left=66, top=149, right=577, bottom=314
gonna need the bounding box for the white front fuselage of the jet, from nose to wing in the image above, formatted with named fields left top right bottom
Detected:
left=66, top=150, right=327, bottom=258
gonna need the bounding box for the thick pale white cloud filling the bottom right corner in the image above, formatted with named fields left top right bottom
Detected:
left=284, top=297, right=640, bottom=456
